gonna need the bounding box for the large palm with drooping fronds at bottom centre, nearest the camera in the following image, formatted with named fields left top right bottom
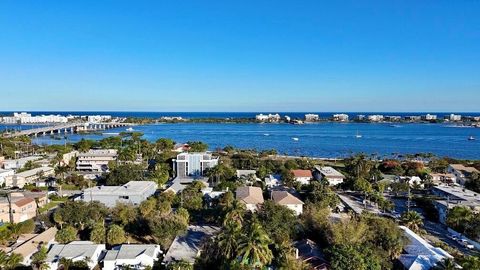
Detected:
left=238, top=222, right=273, bottom=268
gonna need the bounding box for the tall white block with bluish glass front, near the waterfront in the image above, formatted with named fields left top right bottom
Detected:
left=173, top=152, right=218, bottom=178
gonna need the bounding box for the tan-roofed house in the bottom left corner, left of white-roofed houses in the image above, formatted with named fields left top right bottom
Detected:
left=5, top=227, right=57, bottom=266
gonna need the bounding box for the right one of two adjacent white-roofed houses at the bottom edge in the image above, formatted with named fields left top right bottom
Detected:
left=103, top=245, right=162, bottom=270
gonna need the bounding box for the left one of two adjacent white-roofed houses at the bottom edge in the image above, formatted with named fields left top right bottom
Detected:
left=45, top=241, right=105, bottom=269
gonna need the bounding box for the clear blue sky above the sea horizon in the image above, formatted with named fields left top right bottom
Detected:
left=0, top=0, right=480, bottom=111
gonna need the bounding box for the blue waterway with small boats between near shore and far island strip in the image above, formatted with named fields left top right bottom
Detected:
left=0, top=123, right=480, bottom=159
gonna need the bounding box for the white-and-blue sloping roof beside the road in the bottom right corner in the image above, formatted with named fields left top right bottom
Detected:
left=398, top=226, right=453, bottom=270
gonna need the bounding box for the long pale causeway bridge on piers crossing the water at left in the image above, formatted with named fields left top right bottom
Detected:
left=4, top=122, right=134, bottom=138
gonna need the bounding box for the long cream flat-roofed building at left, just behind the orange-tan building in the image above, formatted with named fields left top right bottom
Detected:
left=5, top=167, right=55, bottom=188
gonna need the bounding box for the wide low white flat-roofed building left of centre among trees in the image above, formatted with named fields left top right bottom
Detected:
left=82, top=181, right=157, bottom=207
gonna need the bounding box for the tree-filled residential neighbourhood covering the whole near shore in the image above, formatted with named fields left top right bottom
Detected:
left=0, top=132, right=480, bottom=269
